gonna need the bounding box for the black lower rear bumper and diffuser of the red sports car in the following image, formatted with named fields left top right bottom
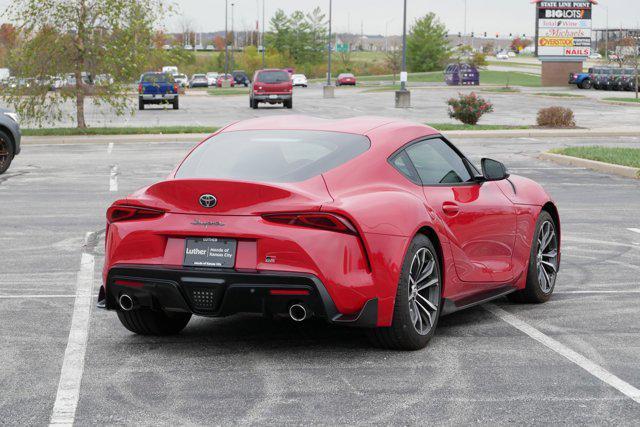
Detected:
left=98, top=264, right=378, bottom=327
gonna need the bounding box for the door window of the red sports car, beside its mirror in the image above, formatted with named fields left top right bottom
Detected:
left=405, top=138, right=471, bottom=185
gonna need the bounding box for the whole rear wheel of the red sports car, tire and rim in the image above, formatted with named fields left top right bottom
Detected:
left=370, top=235, right=442, bottom=350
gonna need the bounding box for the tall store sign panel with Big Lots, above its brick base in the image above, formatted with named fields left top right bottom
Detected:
left=533, top=0, right=597, bottom=61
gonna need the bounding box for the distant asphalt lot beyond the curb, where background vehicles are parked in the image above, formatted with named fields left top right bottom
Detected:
left=10, top=82, right=640, bottom=128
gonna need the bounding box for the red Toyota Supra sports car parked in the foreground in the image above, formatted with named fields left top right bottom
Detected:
left=98, top=116, right=560, bottom=349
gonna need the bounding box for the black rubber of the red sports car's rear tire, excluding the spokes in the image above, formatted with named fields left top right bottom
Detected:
left=368, top=234, right=442, bottom=350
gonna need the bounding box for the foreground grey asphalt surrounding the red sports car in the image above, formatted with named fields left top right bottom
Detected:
left=0, top=138, right=640, bottom=425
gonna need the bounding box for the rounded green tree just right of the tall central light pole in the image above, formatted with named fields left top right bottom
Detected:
left=407, top=12, right=450, bottom=71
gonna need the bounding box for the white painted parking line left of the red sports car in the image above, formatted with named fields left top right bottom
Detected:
left=50, top=233, right=95, bottom=425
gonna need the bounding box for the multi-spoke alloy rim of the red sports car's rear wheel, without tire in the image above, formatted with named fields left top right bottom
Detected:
left=408, top=248, right=440, bottom=335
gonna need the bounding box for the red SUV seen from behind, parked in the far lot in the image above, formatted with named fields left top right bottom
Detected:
left=249, top=69, right=293, bottom=109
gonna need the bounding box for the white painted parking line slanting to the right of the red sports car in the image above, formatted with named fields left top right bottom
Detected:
left=483, top=304, right=640, bottom=403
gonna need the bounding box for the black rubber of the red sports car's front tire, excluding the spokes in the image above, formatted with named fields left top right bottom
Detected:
left=509, top=211, right=559, bottom=304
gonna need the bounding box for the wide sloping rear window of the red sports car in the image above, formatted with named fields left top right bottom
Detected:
left=176, top=130, right=371, bottom=182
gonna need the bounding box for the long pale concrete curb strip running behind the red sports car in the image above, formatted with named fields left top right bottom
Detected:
left=22, top=126, right=640, bottom=145
